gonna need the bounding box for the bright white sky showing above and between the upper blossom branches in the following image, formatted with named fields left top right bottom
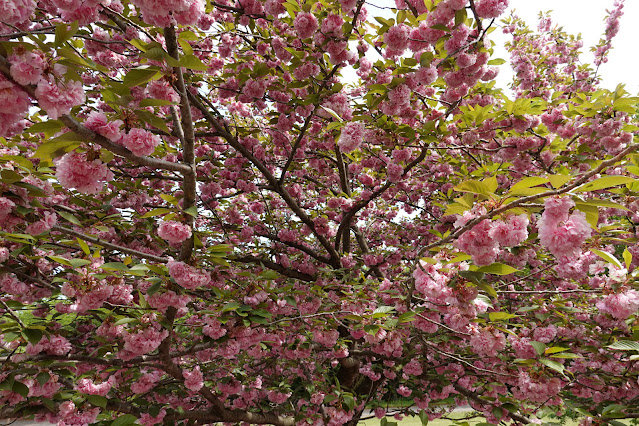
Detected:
left=360, top=0, right=639, bottom=95
